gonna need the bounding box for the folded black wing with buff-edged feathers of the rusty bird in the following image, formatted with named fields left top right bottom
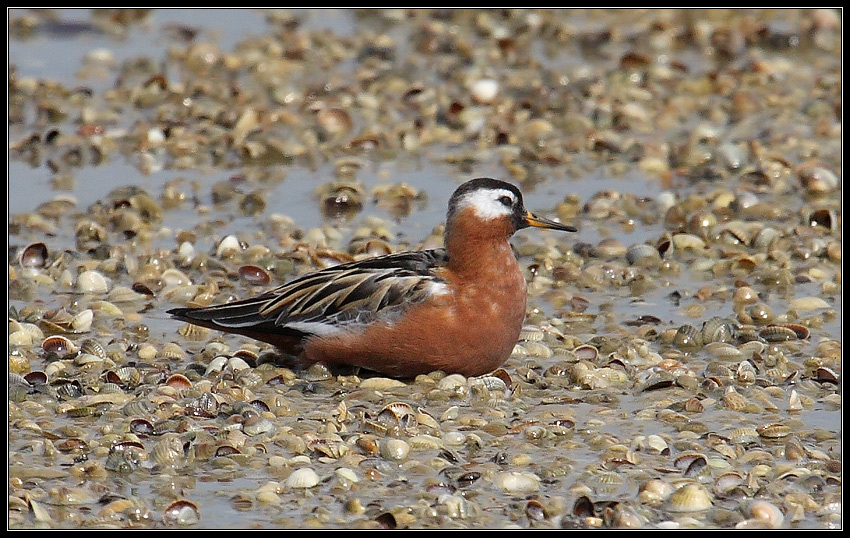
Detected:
left=164, top=249, right=448, bottom=334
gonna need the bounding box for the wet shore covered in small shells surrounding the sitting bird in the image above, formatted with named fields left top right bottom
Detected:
left=7, top=9, right=843, bottom=529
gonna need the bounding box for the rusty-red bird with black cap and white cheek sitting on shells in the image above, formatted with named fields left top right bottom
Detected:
left=167, top=177, right=577, bottom=378
